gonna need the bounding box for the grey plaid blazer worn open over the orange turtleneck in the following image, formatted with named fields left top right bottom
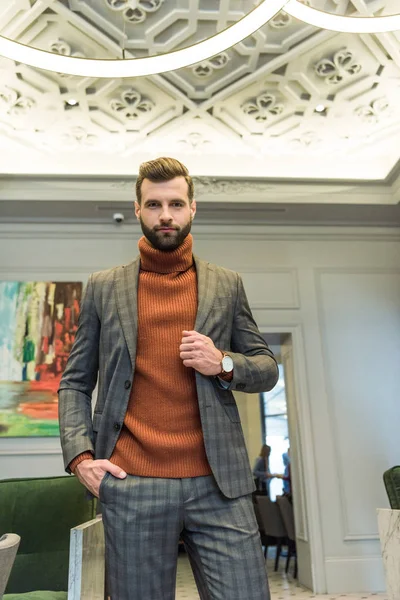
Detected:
left=59, top=257, right=278, bottom=498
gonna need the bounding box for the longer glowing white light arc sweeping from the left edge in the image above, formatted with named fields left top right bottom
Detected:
left=0, top=0, right=289, bottom=78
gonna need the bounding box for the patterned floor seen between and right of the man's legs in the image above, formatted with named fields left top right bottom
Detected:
left=176, top=554, right=387, bottom=600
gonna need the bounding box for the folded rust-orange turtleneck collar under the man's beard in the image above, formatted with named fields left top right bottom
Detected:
left=138, top=233, right=193, bottom=273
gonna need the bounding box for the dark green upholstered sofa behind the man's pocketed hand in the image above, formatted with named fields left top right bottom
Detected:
left=0, top=476, right=96, bottom=600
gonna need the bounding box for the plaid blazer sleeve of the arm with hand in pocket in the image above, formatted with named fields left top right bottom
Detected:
left=58, top=275, right=100, bottom=472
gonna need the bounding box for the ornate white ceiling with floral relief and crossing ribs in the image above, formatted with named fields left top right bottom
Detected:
left=0, top=0, right=400, bottom=188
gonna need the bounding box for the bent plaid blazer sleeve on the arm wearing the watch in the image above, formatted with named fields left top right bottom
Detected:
left=228, top=274, right=279, bottom=393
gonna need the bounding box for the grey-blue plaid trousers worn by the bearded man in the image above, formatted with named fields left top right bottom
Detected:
left=100, top=473, right=270, bottom=600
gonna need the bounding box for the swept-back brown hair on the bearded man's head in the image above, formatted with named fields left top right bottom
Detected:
left=136, top=156, right=194, bottom=204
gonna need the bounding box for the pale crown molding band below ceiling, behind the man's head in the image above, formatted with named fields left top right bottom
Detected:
left=0, top=176, right=400, bottom=205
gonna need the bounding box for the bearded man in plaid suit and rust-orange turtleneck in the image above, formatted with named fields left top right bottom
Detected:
left=59, top=158, right=278, bottom=600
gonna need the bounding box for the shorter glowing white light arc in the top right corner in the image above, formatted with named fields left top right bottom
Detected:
left=284, top=0, right=400, bottom=33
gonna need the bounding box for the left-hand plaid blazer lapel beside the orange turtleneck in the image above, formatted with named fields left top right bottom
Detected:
left=114, top=257, right=140, bottom=366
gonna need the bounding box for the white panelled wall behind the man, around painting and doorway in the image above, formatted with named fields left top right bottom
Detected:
left=0, top=224, right=400, bottom=593
